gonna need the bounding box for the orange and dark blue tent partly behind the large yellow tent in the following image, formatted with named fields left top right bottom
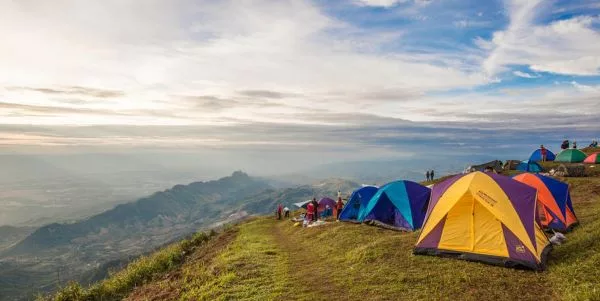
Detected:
left=513, top=173, right=577, bottom=231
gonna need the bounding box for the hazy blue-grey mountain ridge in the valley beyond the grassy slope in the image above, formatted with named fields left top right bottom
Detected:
left=0, top=172, right=358, bottom=300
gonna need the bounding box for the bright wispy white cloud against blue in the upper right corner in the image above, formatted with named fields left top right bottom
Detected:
left=480, top=0, right=600, bottom=75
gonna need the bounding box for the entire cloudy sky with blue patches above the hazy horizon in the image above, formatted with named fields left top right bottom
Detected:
left=0, top=0, right=600, bottom=168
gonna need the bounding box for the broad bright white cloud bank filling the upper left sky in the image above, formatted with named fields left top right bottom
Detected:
left=0, top=0, right=489, bottom=125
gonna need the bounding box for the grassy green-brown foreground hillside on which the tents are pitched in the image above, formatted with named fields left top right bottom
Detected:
left=47, top=155, right=600, bottom=301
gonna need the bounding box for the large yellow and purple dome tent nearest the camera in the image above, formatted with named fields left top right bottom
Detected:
left=414, top=172, right=552, bottom=270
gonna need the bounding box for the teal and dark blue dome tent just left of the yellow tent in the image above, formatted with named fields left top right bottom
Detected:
left=358, top=181, right=431, bottom=231
